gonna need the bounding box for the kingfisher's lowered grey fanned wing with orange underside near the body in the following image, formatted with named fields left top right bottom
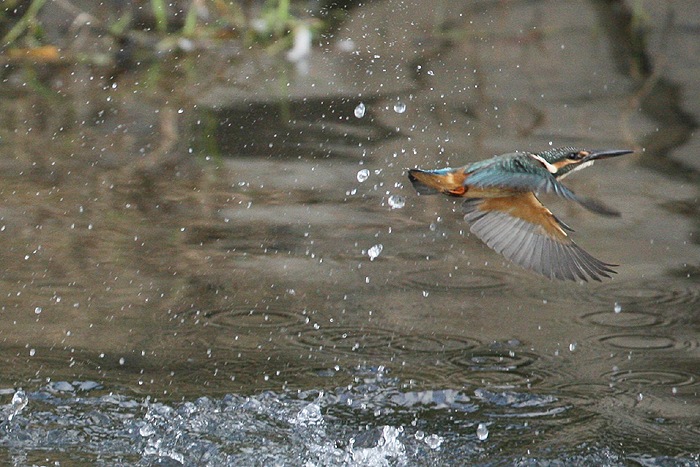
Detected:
left=464, top=192, right=615, bottom=281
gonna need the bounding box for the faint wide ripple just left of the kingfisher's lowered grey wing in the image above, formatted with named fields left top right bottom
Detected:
left=402, top=269, right=508, bottom=292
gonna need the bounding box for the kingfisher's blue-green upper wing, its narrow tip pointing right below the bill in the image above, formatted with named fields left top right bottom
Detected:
left=465, top=153, right=620, bottom=216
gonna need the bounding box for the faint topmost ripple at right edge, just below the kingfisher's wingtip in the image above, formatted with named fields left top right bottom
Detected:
left=577, top=280, right=700, bottom=311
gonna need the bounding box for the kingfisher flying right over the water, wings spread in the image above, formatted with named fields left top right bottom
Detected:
left=408, top=147, right=634, bottom=281
